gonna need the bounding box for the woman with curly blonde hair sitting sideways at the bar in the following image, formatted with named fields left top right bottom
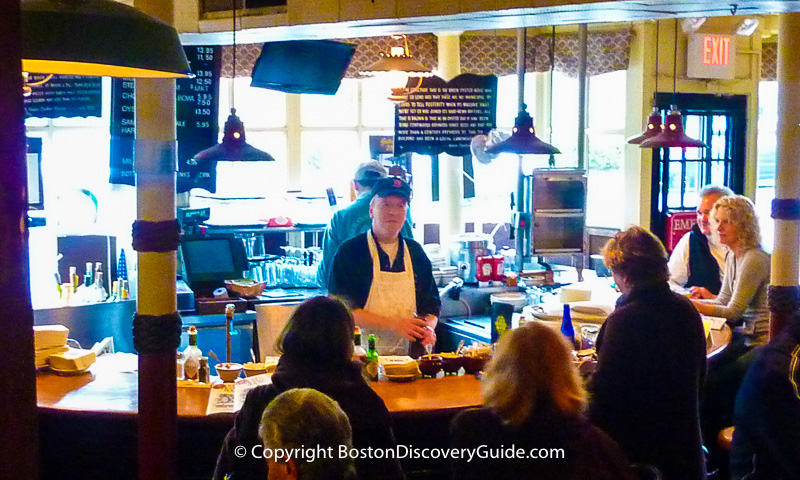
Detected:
left=692, top=195, right=770, bottom=474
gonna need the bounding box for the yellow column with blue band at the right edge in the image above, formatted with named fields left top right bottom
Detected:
left=769, top=13, right=800, bottom=337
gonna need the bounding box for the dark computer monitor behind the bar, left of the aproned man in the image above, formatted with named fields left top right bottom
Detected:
left=181, top=235, right=249, bottom=296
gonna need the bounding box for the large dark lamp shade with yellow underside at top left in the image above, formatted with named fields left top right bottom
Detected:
left=21, top=0, right=192, bottom=78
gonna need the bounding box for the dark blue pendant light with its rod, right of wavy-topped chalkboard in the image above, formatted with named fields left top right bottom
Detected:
left=486, top=28, right=561, bottom=155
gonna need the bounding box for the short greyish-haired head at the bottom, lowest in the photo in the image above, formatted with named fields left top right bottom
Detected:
left=258, top=388, right=355, bottom=480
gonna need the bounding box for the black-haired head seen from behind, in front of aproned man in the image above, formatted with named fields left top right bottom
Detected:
left=278, top=297, right=355, bottom=365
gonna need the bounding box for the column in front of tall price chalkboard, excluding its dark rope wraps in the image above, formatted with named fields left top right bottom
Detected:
left=131, top=0, right=178, bottom=480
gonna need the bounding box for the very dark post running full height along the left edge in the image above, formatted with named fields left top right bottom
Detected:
left=0, top=0, right=39, bottom=479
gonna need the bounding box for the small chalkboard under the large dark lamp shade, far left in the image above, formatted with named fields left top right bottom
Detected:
left=24, top=73, right=103, bottom=118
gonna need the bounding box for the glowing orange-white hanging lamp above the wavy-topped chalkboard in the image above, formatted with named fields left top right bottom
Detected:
left=359, top=34, right=433, bottom=104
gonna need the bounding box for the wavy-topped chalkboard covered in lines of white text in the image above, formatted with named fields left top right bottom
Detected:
left=394, top=73, right=497, bottom=157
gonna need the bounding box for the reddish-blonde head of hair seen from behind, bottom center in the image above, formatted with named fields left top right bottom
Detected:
left=481, top=322, right=586, bottom=427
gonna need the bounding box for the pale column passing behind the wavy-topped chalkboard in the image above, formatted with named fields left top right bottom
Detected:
left=436, top=32, right=464, bottom=255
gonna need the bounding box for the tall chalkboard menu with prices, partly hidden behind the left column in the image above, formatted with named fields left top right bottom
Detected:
left=109, top=46, right=222, bottom=192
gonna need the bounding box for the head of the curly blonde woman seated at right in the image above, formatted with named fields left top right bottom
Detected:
left=711, top=195, right=761, bottom=250
